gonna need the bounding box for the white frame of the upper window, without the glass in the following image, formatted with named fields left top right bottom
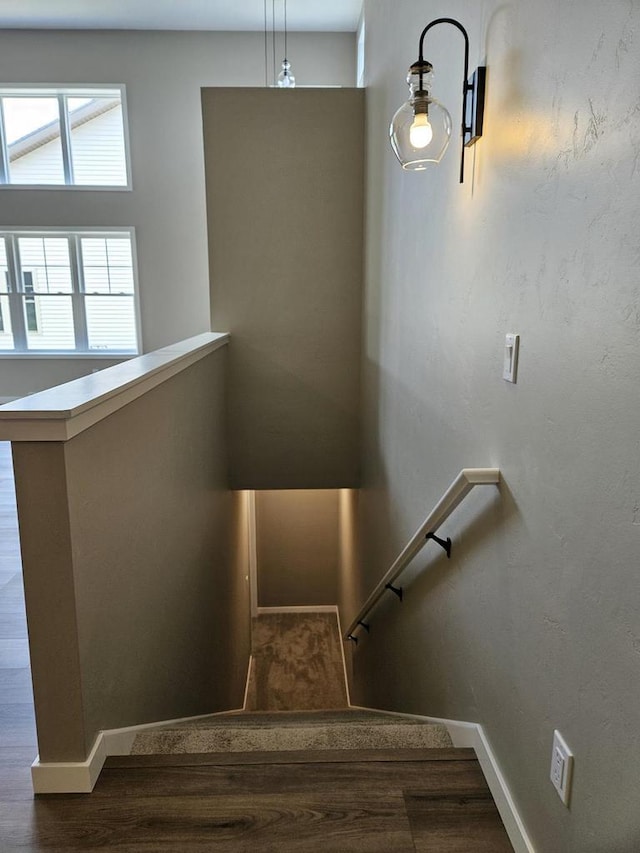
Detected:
left=0, top=83, right=132, bottom=192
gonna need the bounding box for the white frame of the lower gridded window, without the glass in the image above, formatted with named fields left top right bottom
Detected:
left=0, top=227, right=142, bottom=360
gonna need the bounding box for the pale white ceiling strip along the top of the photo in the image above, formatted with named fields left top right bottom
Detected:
left=0, top=0, right=362, bottom=32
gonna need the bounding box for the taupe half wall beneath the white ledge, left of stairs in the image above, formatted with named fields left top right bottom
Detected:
left=13, top=350, right=249, bottom=761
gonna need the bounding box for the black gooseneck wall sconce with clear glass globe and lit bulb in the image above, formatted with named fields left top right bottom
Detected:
left=389, top=18, right=487, bottom=183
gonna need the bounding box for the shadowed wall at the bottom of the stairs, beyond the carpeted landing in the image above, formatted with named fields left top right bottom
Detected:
left=256, top=489, right=340, bottom=607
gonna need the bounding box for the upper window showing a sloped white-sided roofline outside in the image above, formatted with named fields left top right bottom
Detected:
left=0, top=87, right=130, bottom=187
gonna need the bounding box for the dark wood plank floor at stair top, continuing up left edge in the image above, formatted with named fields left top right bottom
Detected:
left=0, top=442, right=512, bottom=853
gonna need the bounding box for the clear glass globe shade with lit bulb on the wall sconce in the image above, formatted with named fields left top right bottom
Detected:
left=389, top=62, right=451, bottom=172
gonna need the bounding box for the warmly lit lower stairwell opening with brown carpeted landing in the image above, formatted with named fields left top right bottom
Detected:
left=240, top=489, right=357, bottom=710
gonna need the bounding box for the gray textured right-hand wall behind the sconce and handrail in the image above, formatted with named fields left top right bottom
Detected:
left=354, top=0, right=640, bottom=853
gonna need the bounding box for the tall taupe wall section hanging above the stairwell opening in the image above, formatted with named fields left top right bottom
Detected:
left=203, top=89, right=364, bottom=489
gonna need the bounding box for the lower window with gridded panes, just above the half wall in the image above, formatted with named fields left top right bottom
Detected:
left=0, top=231, right=139, bottom=355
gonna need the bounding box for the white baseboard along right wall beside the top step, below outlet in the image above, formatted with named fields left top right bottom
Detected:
left=352, top=705, right=535, bottom=853
